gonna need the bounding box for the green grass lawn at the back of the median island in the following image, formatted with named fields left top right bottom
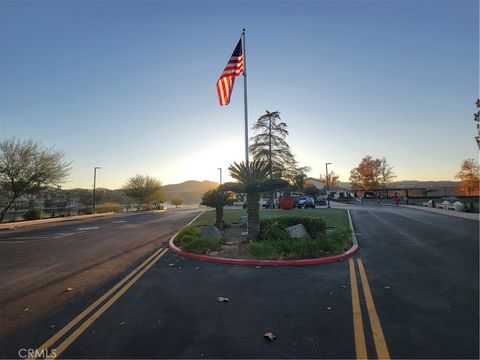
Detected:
left=193, top=209, right=350, bottom=229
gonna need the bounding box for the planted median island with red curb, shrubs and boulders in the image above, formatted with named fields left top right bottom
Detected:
left=169, top=209, right=359, bottom=266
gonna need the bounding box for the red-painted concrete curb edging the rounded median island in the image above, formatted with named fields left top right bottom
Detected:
left=168, top=210, right=360, bottom=266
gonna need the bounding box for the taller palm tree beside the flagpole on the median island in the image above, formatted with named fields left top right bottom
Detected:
left=221, top=159, right=288, bottom=240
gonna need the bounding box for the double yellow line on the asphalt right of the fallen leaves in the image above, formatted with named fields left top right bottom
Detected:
left=348, top=258, right=390, bottom=359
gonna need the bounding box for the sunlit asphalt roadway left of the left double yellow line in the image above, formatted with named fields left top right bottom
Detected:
left=0, top=209, right=200, bottom=358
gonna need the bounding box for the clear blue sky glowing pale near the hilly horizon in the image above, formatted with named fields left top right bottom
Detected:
left=0, top=0, right=479, bottom=189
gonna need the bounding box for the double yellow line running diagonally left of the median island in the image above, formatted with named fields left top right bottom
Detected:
left=30, top=249, right=168, bottom=359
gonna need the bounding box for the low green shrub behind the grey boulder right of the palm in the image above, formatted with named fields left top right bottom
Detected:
left=260, top=216, right=327, bottom=240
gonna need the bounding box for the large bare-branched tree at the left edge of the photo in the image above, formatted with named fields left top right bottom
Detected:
left=0, top=138, right=70, bottom=222
